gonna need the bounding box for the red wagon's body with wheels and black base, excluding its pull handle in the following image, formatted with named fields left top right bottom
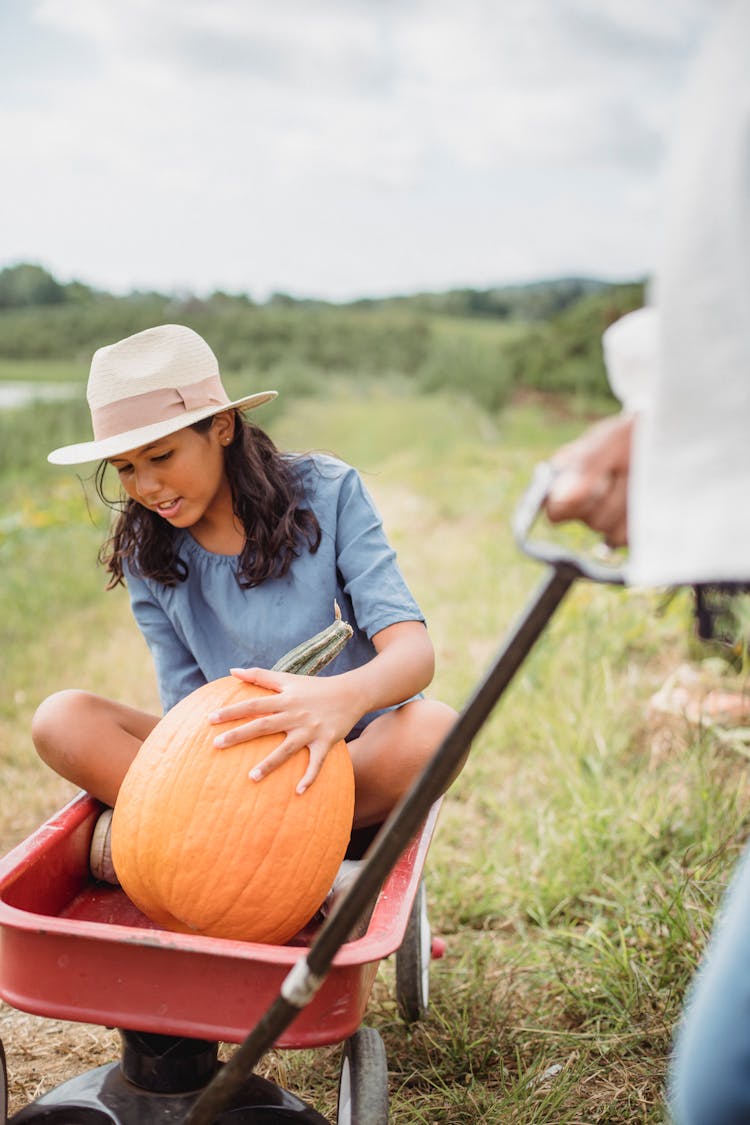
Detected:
left=0, top=794, right=440, bottom=1125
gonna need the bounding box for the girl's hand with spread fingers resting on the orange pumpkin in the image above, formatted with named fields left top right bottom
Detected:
left=209, top=668, right=361, bottom=793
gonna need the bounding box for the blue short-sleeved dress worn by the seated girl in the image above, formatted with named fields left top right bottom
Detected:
left=126, top=455, right=424, bottom=729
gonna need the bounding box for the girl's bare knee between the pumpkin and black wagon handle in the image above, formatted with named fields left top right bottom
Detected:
left=349, top=700, right=455, bottom=828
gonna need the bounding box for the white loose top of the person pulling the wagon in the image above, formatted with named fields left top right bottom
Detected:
left=604, top=0, right=750, bottom=585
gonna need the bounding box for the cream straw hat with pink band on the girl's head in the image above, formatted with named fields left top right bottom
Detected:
left=47, top=324, right=277, bottom=465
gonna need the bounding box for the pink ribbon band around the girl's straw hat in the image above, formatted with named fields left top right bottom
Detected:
left=91, top=375, right=229, bottom=441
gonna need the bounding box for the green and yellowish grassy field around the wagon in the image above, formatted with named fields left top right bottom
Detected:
left=0, top=384, right=748, bottom=1125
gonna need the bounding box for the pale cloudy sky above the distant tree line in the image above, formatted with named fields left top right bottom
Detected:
left=0, top=0, right=719, bottom=300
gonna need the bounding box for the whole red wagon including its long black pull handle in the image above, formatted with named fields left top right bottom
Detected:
left=0, top=466, right=624, bottom=1125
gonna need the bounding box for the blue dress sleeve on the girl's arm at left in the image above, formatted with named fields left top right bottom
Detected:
left=127, top=570, right=206, bottom=711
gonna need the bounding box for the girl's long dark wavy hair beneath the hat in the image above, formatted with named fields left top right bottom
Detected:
left=94, top=411, right=320, bottom=590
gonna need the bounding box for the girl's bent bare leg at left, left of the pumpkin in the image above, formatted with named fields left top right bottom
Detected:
left=31, top=691, right=159, bottom=806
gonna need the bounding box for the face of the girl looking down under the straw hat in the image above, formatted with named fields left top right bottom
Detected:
left=109, top=413, right=234, bottom=539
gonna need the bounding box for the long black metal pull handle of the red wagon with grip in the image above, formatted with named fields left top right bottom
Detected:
left=183, top=465, right=624, bottom=1125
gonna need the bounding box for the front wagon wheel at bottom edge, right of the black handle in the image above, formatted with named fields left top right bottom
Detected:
left=336, top=1027, right=388, bottom=1125
